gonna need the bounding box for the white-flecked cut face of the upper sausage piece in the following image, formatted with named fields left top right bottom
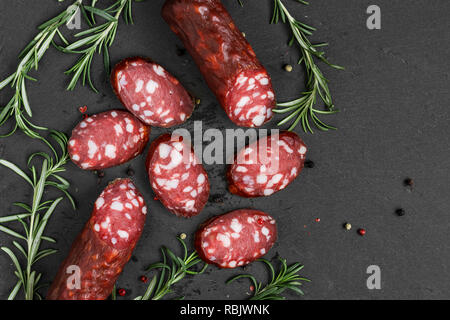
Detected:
left=225, top=69, right=275, bottom=127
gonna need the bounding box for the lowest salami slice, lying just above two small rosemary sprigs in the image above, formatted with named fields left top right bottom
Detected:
left=195, top=209, right=277, bottom=268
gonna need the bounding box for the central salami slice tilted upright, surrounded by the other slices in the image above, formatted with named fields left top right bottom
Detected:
left=146, top=134, right=209, bottom=218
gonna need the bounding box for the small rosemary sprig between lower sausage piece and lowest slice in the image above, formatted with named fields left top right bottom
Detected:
left=135, top=238, right=208, bottom=300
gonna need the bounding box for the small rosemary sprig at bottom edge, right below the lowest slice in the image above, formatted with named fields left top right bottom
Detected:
left=227, top=258, right=310, bottom=300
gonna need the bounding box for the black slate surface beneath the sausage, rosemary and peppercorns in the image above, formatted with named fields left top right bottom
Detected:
left=0, top=0, right=450, bottom=299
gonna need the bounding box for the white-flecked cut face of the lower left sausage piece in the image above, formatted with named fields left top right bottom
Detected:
left=89, top=179, right=147, bottom=250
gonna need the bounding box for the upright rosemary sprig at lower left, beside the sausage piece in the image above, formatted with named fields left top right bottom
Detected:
left=0, top=131, right=75, bottom=300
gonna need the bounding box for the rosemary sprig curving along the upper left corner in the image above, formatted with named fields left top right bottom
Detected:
left=0, top=0, right=82, bottom=142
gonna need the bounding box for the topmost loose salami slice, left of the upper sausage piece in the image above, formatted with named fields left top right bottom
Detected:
left=111, top=57, right=194, bottom=128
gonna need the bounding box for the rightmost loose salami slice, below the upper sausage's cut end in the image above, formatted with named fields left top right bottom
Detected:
left=227, top=131, right=307, bottom=197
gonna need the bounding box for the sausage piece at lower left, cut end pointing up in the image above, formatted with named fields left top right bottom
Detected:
left=47, top=179, right=147, bottom=300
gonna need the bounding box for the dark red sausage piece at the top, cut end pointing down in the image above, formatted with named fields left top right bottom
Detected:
left=162, top=0, right=275, bottom=127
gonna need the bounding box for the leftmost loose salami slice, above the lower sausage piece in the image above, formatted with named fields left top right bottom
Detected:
left=68, top=110, right=150, bottom=170
